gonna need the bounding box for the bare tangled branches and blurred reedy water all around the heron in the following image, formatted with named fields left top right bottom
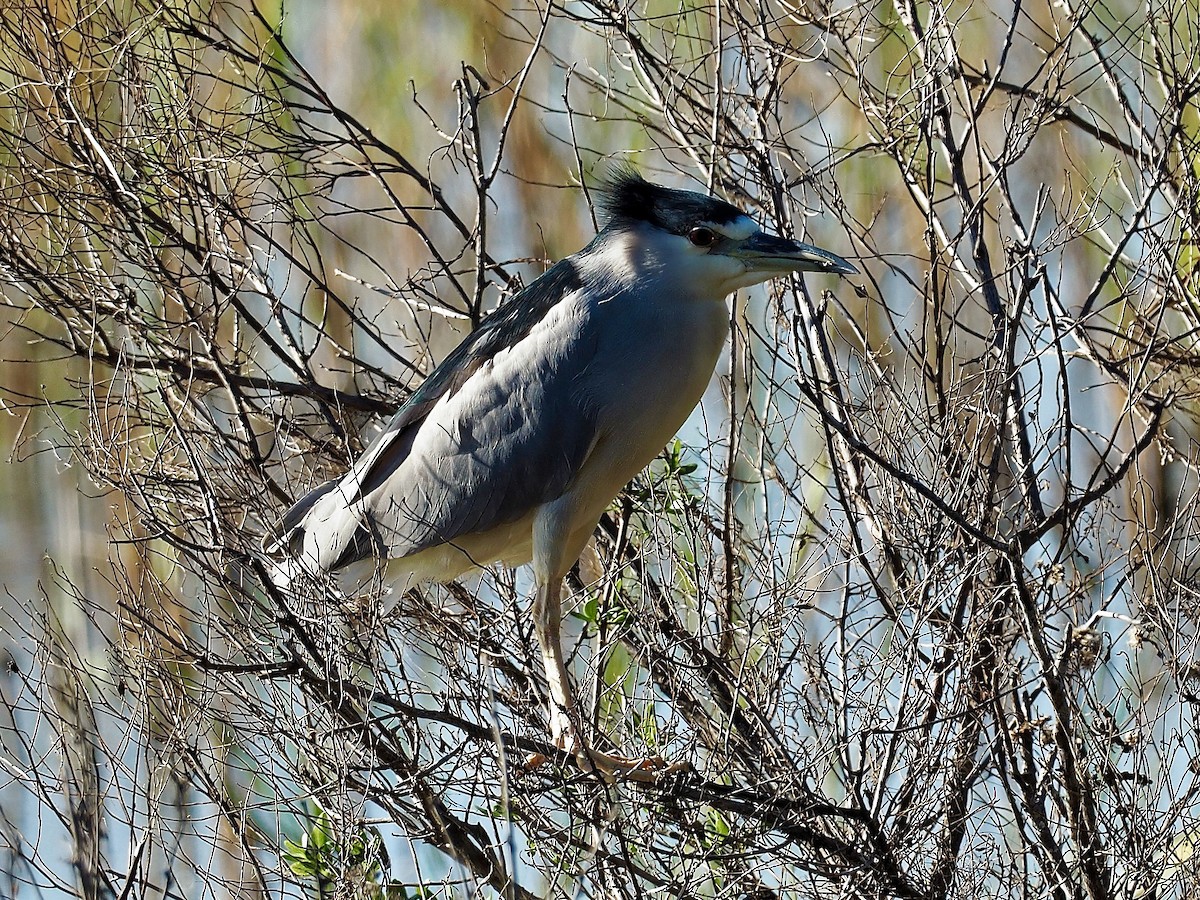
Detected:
left=0, top=0, right=1200, bottom=900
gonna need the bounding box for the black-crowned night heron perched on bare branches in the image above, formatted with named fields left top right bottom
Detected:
left=264, top=172, right=857, bottom=778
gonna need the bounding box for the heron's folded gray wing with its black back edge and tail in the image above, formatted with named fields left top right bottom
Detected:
left=264, top=259, right=595, bottom=571
